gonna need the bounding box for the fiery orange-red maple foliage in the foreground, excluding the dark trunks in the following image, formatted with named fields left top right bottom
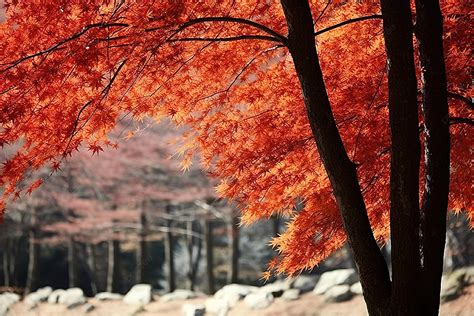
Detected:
left=0, top=0, right=474, bottom=274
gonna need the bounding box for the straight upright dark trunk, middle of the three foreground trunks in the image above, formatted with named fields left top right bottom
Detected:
left=381, top=0, right=422, bottom=315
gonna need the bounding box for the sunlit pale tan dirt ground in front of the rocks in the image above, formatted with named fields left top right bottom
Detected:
left=8, top=285, right=474, bottom=316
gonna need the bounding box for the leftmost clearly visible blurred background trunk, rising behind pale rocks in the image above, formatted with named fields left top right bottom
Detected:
left=25, top=208, right=40, bottom=294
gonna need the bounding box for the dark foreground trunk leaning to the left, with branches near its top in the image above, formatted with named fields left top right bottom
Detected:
left=281, top=0, right=390, bottom=315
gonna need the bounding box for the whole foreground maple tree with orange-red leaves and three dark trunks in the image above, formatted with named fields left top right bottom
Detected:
left=0, top=0, right=473, bottom=315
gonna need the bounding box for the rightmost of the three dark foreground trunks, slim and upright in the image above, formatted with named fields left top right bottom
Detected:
left=415, top=0, right=450, bottom=315
